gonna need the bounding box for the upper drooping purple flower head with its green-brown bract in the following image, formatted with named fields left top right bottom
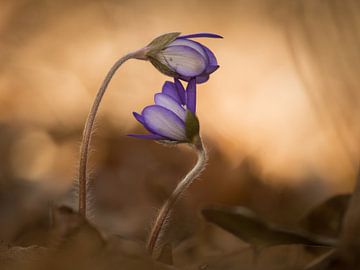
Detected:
left=146, top=33, right=222, bottom=83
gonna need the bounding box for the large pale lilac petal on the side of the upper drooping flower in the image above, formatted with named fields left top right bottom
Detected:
left=159, top=45, right=207, bottom=77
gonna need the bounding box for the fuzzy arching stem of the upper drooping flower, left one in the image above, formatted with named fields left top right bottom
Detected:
left=79, top=49, right=146, bottom=217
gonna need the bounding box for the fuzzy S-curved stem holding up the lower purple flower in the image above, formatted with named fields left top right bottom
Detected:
left=147, top=137, right=208, bottom=255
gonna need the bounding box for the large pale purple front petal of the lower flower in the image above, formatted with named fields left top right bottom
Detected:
left=142, top=105, right=186, bottom=141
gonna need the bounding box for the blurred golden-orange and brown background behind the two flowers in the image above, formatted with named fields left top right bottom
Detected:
left=0, top=0, right=360, bottom=249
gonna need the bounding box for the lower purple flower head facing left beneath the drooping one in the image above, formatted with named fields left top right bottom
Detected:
left=129, top=79, right=199, bottom=143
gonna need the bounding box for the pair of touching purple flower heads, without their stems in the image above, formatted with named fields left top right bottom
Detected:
left=129, top=33, right=221, bottom=143
